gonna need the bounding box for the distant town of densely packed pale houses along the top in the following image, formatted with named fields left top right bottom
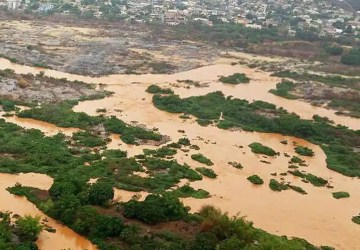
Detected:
left=0, top=0, right=360, bottom=38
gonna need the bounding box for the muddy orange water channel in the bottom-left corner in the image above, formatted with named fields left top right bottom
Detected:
left=0, top=173, right=97, bottom=250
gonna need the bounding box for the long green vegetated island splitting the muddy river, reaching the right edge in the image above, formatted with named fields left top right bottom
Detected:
left=153, top=92, right=360, bottom=176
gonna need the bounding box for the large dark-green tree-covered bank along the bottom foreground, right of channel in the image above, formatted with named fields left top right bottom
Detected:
left=10, top=178, right=328, bottom=250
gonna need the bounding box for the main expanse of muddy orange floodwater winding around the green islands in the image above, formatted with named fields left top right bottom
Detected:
left=0, top=57, right=360, bottom=249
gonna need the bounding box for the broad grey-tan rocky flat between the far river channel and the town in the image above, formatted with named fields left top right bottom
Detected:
left=0, top=16, right=218, bottom=76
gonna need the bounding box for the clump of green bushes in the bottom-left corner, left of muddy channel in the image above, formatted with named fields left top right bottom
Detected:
left=0, top=212, right=43, bottom=250
